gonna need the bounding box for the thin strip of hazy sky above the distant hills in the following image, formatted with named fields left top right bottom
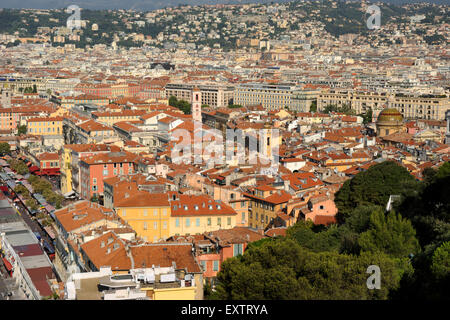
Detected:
left=0, top=0, right=444, bottom=11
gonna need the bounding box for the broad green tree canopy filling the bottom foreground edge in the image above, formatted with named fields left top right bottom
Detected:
left=213, top=238, right=412, bottom=300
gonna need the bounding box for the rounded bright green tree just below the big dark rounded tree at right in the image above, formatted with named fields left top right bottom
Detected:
left=358, top=210, right=420, bottom=258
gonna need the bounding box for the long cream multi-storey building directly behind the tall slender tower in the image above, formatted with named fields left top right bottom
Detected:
left=166, top=83, right=234, bottom=108
